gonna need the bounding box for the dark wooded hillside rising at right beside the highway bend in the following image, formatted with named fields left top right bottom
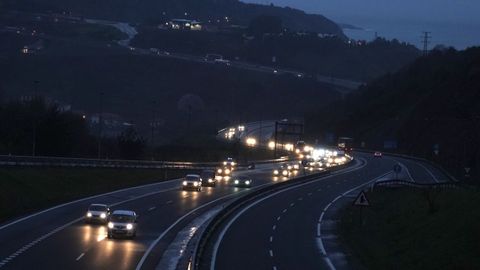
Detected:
left=307, top=47, right=480, bottom=179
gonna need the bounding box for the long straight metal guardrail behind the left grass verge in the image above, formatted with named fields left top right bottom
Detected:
left=0, top=155, right=288, bottom=169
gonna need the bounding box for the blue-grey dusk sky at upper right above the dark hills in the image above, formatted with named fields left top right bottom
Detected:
left=244, top=0, right=480, bottom=48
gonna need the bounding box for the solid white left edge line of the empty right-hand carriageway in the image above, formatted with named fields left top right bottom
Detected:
left=210, top=159, right=367, bottom=270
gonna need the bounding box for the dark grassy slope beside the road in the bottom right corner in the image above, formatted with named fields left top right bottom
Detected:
left=340, top=188, right=480, bottom=270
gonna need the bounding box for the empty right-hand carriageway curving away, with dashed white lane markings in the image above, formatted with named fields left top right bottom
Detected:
left=205, top=154, right=448, bottom=270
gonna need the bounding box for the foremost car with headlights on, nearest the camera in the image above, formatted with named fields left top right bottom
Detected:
left=107, top=210, right=138, bottom=238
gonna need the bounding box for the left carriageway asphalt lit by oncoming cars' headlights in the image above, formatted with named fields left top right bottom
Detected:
left=0, top=161, right=300, bottom=269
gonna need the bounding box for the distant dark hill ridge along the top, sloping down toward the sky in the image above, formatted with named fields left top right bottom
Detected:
left=2, top=0, right=343, bottom=37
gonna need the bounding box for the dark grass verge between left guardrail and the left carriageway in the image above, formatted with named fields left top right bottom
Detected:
left=0, top=167, right=195, bottom=222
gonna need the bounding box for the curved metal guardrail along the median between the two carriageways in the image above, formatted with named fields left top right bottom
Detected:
left=190, top=159, right=350, bottom=270
